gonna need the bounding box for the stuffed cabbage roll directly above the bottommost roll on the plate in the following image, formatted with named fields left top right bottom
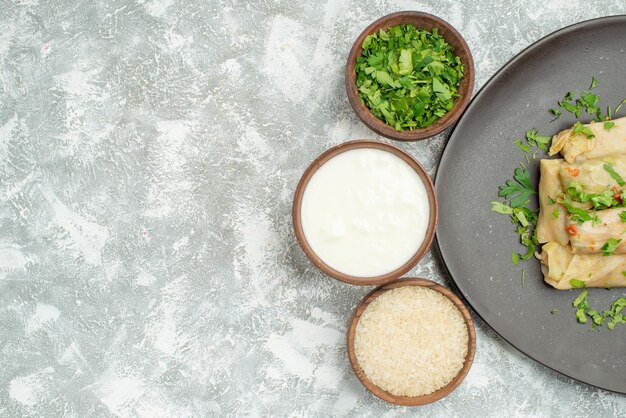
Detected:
left=565, top=208, right=626, bottom=255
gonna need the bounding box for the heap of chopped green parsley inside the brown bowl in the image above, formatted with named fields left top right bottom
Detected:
left=355, top=24, right=464, bottom=131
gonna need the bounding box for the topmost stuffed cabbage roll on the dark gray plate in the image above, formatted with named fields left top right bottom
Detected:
left=550, top=117, right=626, bottom=163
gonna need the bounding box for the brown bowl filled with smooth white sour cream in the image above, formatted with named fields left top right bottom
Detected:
left=293, top=140, right=437, bottom=285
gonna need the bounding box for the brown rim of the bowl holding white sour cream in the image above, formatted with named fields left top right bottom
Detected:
left=292, top=139, right=439, bottom=286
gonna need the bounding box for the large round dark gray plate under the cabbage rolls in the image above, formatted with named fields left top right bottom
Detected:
left=435, top=16, right=626, bottom=393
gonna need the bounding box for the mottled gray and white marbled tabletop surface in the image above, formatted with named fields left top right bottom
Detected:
left=0, top=0, right=626, bottom=417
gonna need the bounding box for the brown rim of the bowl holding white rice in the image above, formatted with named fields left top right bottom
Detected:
left=347, top=277, right=476, bottom=406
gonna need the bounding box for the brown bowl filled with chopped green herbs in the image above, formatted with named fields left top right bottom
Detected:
left=345, top=11, right=474, bottom=141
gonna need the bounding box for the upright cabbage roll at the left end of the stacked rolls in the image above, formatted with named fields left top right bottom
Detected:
left=537, top=159, right=569, bottom=245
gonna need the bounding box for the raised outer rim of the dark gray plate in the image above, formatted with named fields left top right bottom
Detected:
left=434, top=15, right=626, bottom=395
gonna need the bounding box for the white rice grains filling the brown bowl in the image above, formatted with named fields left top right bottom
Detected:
left=354, top=286, right=469, bottom=396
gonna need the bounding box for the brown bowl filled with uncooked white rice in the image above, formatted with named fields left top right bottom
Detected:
left=347, top=278, right=476, bottom=406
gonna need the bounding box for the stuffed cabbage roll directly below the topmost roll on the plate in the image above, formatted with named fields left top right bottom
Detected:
left=560, top=155, right=626, bottom=194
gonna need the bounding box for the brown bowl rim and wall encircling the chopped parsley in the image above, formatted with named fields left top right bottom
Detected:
left=345, top=11, right=474, bottom=141
